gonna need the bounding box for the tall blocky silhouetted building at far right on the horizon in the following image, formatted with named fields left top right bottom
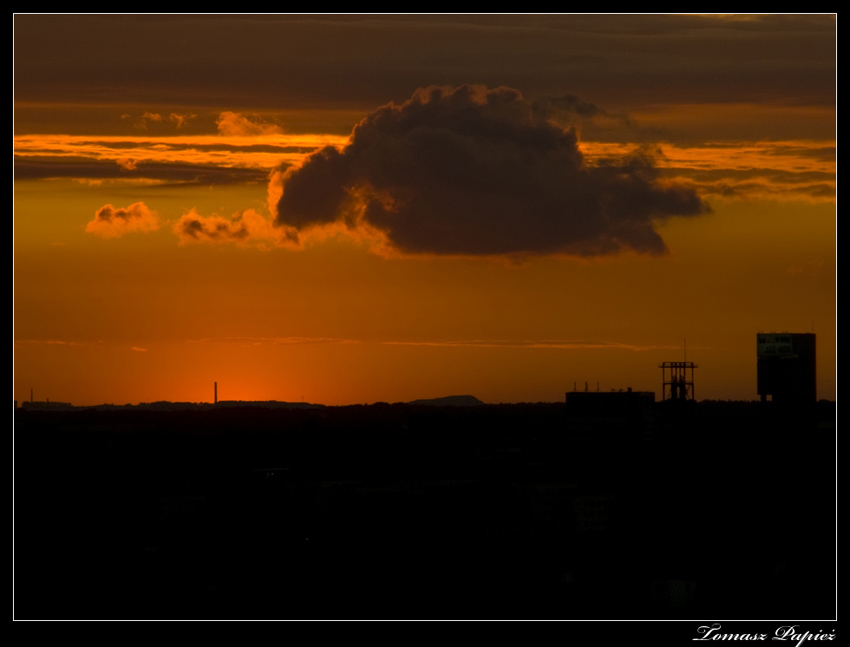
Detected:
left=756, top=333, right=817, bottom=405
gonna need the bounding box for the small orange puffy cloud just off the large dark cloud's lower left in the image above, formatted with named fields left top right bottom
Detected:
left=172, top=209, right=295, bottom=249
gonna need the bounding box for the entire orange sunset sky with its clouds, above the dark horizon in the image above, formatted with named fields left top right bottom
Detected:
left=13, top=15, right=836, bottom=405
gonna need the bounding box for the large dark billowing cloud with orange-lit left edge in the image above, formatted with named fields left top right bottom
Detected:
left=276, top=85, right=710, bottom=256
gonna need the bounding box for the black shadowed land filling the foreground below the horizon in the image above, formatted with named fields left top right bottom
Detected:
left=14, top=402, right=836, bottom=620
